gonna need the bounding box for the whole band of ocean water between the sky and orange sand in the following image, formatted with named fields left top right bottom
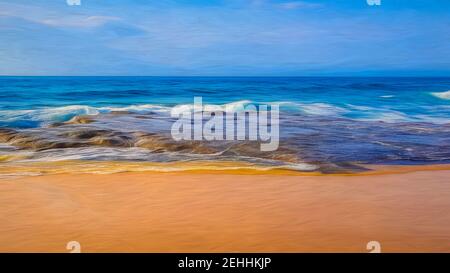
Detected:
left=0, top=77, right=450, bottom=172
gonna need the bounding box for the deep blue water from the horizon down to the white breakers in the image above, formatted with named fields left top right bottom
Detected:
left=0, top=77, right=450, bottom=127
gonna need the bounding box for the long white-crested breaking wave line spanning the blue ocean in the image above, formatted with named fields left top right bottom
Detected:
left=0, top=98, right=450, bottom=128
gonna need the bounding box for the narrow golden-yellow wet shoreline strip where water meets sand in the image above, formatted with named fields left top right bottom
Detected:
left=0, top=160, right=450, bottom=176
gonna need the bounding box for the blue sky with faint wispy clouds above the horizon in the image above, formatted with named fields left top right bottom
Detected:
left=0, top=0, right=450, bottom=76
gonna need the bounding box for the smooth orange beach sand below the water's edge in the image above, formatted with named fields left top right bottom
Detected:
left=0, top=167, right=450, bottom=252
